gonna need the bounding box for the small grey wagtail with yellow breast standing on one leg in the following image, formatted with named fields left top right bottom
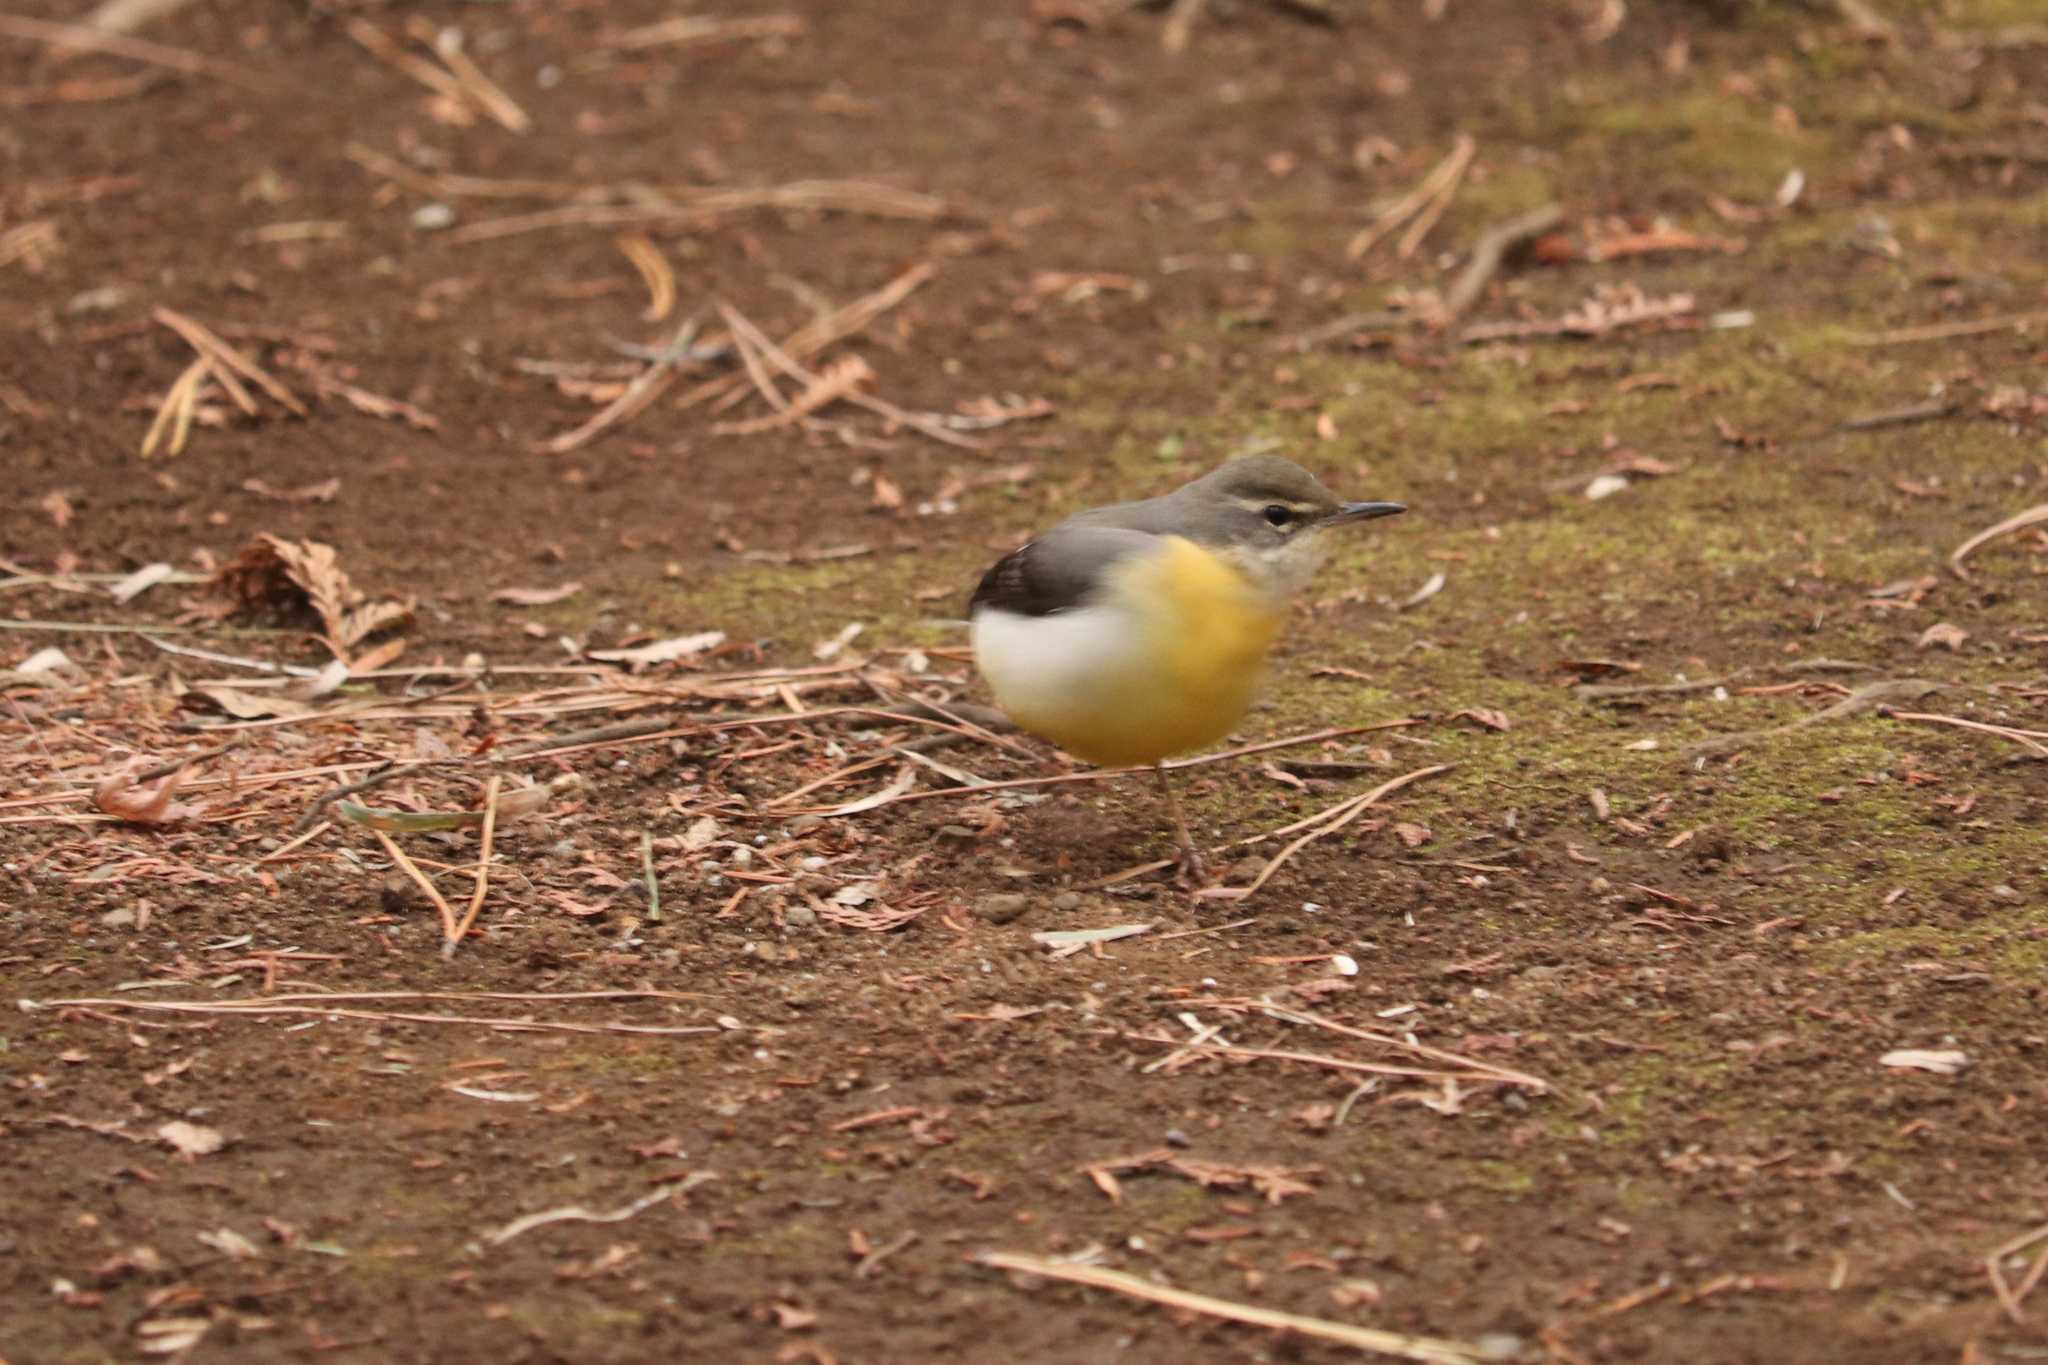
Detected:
left=969, top=454, right=1407, bottom=880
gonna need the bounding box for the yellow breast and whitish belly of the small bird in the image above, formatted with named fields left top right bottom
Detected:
left=989, top=536, right=1280, bottom=763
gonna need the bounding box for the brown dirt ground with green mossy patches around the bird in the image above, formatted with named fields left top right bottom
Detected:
left=0, top=0, right=2048, bottom=1365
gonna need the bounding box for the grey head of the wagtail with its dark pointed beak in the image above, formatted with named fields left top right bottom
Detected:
left=1171, top=454, right=1405, bottom=589
